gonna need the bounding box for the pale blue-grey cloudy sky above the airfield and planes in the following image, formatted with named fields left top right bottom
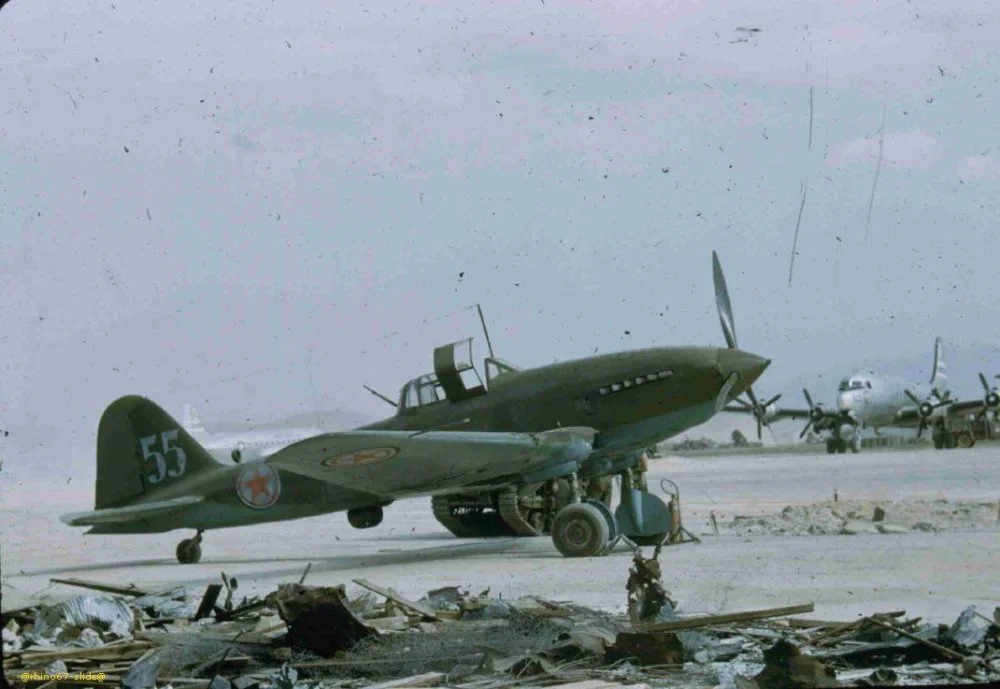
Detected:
left=0, top=0, right=1000, bottom=472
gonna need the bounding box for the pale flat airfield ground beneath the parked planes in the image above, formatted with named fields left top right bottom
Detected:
left=2, top=445, right=1000, bottom=622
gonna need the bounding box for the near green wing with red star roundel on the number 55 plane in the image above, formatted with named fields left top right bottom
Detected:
left=265, top=428, right=596, bottom=498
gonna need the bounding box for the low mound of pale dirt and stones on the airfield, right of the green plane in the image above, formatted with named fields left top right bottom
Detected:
left=718, top=500, right=1000, bottom=536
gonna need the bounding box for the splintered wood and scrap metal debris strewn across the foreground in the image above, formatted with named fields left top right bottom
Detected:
left=3, top=564, right=1000, bottom=689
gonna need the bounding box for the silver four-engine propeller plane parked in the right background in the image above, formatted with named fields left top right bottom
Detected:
left=726, top=337, right=1000, bottom=454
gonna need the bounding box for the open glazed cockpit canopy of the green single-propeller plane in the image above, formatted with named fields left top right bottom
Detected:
left=399, top=337, right=521, bottom=412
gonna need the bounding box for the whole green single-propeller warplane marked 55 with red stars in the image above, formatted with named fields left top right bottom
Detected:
left=61, top=252, right=770, bottom=563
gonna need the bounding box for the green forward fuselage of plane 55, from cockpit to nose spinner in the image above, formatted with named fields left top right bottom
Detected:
left=363, top=347, right=769, bottom=456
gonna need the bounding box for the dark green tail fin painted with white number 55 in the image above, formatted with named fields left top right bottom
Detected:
left=94, top=395, right=220, bottom=510
